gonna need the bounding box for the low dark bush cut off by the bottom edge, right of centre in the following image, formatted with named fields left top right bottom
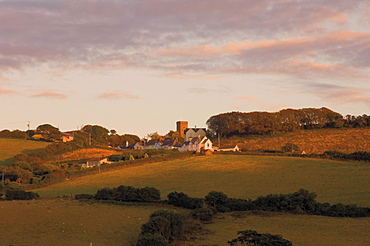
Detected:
left=228, top=230, right=293, bottom=246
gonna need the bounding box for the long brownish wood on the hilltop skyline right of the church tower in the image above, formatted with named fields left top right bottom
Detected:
left=207, top=107, right=370, bottom=137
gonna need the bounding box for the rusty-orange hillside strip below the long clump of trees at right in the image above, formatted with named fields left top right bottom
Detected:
left=220, top=128, right=370, bottom=154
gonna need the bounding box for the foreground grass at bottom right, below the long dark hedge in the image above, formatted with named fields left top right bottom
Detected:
left=181, top=212, right=370, bottom=246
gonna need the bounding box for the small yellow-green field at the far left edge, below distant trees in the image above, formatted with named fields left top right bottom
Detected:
left=0, top=138, right=50, bottom=166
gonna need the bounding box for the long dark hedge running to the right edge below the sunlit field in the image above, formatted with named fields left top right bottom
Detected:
left=168, top=189, right=370, bottom=218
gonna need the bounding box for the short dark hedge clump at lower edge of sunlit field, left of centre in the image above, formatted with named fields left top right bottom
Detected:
left=95, top=185, right=161, bottom=202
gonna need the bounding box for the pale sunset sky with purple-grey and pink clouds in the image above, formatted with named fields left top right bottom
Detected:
left=0, top=0, right=370, bottom=137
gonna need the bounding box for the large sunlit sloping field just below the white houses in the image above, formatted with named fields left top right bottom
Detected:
left=35, top=155, right=370, bottom=207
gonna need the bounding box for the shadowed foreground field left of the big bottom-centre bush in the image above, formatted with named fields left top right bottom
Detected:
left=0, top=199, right=171, bottom=246
